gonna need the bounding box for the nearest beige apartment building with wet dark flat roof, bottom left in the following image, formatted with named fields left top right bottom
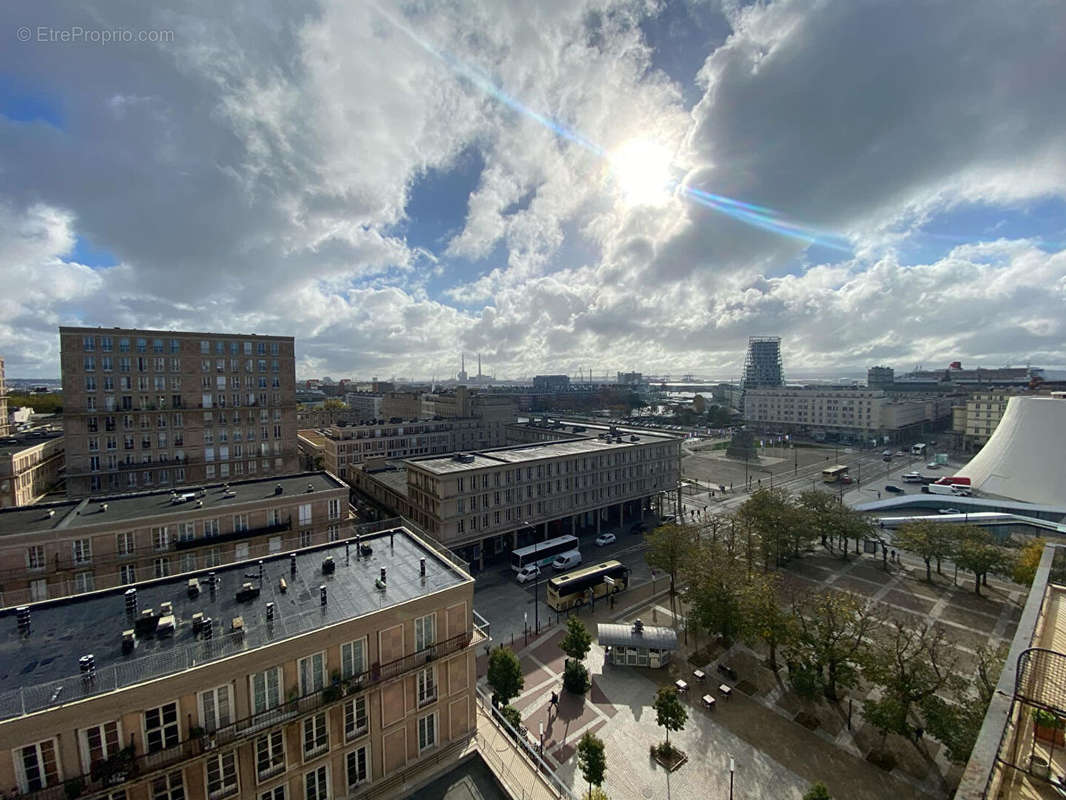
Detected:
left=0, top=527, right=485, bottom=800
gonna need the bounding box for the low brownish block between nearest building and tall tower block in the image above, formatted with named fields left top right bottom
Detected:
left=0, top=473, right=352, bottom=606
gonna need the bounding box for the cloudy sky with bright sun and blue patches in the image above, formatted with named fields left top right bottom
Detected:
left=0, top=0, right=1066, bottom=379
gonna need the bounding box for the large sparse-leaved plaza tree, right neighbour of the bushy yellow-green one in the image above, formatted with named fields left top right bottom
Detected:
left=862, top=620, right=958, bottom=746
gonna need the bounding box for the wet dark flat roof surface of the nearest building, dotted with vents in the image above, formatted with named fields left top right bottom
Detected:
left=0, top=528, right=472, bottom=719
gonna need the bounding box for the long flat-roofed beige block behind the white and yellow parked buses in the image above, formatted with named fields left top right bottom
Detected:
left=353, top=431, right=681, bottom=565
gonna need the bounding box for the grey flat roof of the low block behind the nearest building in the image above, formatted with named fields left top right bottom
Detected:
left=0, top=473, right=348, bottom=535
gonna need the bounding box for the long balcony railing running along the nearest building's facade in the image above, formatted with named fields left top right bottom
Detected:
left=15, top=628, right=482, bottom=800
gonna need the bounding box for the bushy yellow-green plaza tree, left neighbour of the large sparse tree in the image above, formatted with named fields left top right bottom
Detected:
left=788, top=590, right=873, bottom=700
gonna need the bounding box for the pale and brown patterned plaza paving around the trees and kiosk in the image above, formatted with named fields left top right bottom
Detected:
left=480, top=553, right=1025, bottom=800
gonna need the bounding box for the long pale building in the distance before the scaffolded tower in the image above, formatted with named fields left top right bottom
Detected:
left=744, top=386, right=950, bottom=441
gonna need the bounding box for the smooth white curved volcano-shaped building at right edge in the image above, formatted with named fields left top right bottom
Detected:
left=958, top=397, right=1066, bottom=506
